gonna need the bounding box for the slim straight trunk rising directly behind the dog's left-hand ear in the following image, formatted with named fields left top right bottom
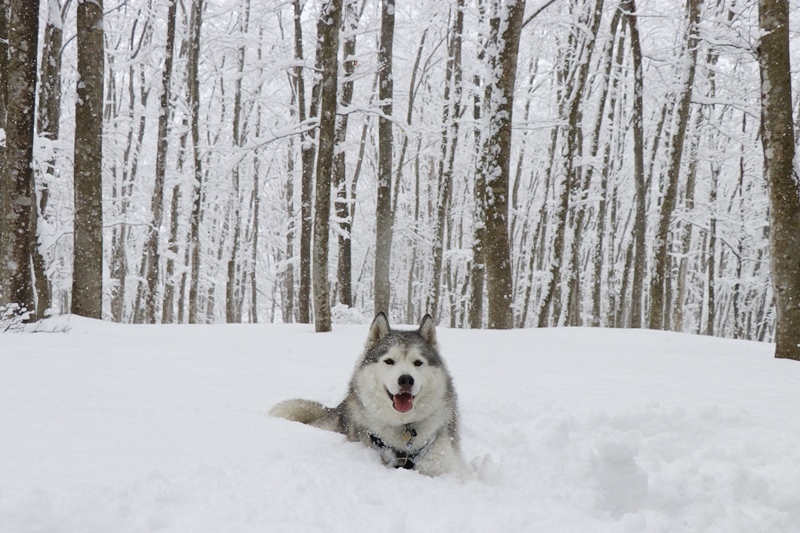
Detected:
left=374, top=0, right=394, bottom=313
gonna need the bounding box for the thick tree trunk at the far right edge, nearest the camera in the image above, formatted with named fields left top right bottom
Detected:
left=758, top=0, right=800, bottom=361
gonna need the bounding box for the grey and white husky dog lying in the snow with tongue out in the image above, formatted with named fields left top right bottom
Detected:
left=270, top=312, right=465, bottom=476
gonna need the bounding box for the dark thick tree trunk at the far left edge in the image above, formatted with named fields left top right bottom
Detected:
left=0, top=0, right=39, bottom=314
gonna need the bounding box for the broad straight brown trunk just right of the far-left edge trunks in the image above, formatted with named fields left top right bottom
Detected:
left=72, top=0, right=105, bottom=318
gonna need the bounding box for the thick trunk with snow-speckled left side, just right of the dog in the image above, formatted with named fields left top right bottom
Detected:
left=478, top=0, right=525, bottom=329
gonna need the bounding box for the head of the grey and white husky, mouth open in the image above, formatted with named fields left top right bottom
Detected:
left=357, top=312, right=450, bottom=423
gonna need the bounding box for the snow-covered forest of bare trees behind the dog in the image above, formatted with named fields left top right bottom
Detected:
left=0, top=0, right=800, bottom=357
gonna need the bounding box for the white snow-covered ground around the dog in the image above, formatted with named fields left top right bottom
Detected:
left=0, top=317, right=800, bottom=533
